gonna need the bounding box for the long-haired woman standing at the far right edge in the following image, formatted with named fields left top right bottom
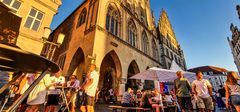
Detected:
left=225, top=71, right=240, bottom=112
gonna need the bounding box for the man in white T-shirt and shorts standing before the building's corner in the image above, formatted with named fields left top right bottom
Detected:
left=80, top=64, right=99, bottom=112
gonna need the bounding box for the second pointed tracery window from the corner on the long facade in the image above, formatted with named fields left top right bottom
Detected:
left=128, top=20, right=137, bottom=47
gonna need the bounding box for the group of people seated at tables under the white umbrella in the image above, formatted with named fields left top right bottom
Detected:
left=121, top=88, right=176, bottom=112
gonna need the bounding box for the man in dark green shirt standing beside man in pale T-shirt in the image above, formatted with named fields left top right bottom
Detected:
left=174, top=71, right=193, bottom=112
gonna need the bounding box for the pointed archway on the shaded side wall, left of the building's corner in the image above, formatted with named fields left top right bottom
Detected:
left=67, top=48, right=85, bottom=80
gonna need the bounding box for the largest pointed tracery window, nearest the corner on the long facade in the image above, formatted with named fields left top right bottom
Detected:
left=106, top=5, right=120, bottom=36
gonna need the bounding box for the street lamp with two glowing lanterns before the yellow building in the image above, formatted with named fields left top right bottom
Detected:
left=42, top=27, right=65, bottom=60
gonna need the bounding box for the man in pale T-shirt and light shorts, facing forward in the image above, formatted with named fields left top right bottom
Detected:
left=192, top=72, right=214, bottom=112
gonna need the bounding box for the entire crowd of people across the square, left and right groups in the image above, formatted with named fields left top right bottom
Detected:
left=1, top=67, right=240, bottom=112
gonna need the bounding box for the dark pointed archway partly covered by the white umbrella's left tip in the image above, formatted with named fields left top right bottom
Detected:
left=125, top=60, right=141, bottom=90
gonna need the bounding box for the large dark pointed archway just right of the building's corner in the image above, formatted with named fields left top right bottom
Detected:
left=98, top=51, right=122, bottom=102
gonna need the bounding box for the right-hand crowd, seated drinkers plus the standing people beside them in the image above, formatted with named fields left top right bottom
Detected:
left=121, top=71, right=240, bottom=112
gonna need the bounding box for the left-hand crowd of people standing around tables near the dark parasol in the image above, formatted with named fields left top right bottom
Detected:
left=1, top=64, right=99, bottom=112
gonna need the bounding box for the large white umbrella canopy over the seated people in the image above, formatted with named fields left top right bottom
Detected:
left=130, top=67, right=195, bottom=82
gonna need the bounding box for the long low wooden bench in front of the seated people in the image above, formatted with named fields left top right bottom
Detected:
left=109, top=105, right=151, bottom=112
